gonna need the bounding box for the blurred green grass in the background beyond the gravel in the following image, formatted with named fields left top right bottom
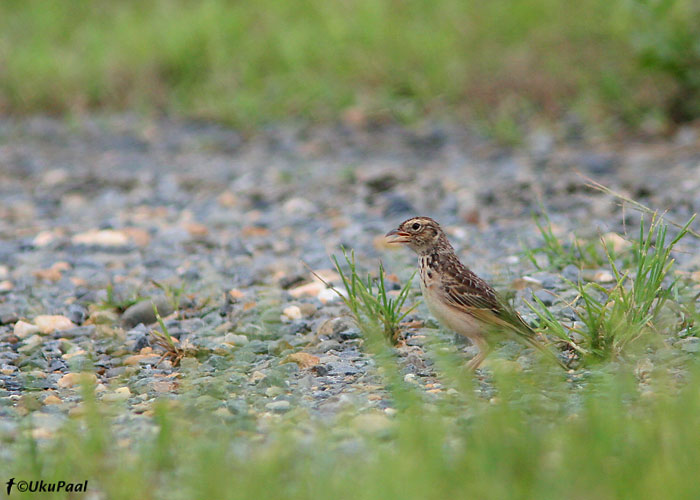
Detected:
left=0, top=0, right=700, bottom=139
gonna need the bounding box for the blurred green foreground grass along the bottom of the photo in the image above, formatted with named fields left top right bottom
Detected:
left=5, top=360, right=700, bottom=500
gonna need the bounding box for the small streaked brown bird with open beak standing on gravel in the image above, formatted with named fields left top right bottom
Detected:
left=386, top=217, right=566, bottom=370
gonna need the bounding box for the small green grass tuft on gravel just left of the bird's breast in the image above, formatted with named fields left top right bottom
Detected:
left=316, top=249, right=417, bottom=344
